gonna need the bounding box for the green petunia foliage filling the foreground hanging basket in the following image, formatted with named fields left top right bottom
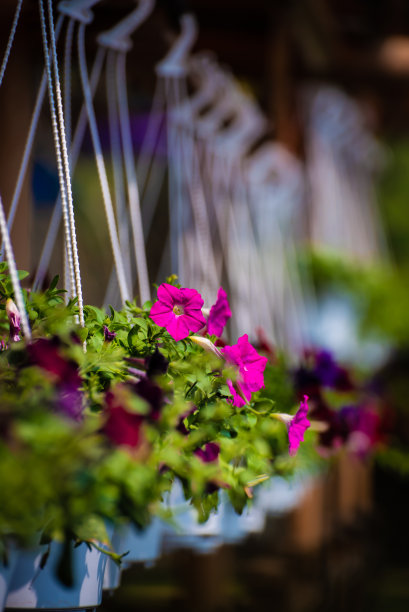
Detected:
left=0, top=264, right=310, bottom=540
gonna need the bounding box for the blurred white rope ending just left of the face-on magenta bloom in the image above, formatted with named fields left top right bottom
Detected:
left=116, top=53, right=150, bottom=304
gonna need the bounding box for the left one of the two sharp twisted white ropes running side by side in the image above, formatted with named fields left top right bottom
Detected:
left=39, top=0, right=75, bottom=302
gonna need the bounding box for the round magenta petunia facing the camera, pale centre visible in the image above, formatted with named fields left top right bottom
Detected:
left=150, top=283, right=206, bottom=341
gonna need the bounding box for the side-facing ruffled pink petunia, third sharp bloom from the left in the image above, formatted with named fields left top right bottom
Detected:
left=222, top=334, right=268, bottom=408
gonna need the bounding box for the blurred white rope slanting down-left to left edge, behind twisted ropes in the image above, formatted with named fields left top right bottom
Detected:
left=0, top=15, right=64, bottom=260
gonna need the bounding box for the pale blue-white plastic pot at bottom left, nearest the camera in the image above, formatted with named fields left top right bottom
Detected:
left=6, top=542, right=107, bottom=610
